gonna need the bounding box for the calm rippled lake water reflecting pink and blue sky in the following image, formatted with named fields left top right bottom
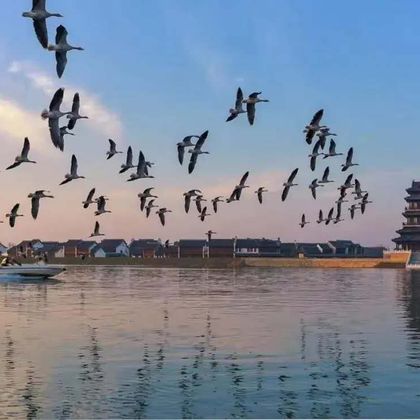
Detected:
left=0, top=267, right=420, bottom=418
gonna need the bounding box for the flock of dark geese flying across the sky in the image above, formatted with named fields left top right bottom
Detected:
left=6, top=0, right=371, bottom=239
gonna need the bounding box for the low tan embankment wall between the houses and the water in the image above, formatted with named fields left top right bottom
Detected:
left=38, top=257, right=405, bottom=269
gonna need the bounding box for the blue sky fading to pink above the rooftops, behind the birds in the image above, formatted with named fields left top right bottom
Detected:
left=0, top=0, right=420, bottom=246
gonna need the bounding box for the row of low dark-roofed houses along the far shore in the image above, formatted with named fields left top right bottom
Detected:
left=3, top=238, right=385, bottom=258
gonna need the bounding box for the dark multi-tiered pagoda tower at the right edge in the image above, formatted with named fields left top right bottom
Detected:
left=393, top=181, right=420, bottom=251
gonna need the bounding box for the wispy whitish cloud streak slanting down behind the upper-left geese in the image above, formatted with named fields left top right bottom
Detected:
left=8, top=61, right=123, bottom=138
